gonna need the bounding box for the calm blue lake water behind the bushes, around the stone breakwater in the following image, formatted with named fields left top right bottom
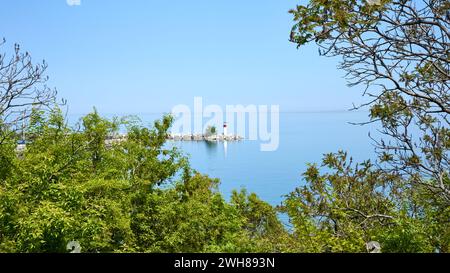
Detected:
left=70, top=112, right=375, bottom=205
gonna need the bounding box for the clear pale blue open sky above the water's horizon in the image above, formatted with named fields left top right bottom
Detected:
left=0, top=0, right=361, bottom=114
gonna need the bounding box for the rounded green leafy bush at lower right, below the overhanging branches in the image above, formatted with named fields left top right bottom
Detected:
left=281, top=152, right=450, bottom=252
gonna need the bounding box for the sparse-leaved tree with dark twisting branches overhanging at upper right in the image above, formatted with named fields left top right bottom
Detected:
left=291, top=0, right=450, bottom=206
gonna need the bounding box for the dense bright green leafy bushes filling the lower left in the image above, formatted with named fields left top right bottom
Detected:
left=0, top=108, right=282, bottom=252
